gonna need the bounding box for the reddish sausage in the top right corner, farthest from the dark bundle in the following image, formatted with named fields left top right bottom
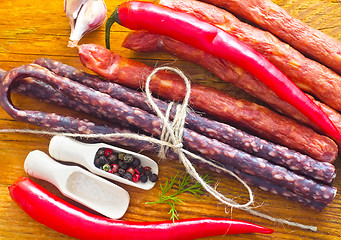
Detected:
left=203, top=0, right=341, bottom=74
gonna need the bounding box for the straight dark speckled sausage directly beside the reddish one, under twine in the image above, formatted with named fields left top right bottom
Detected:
left=35, top=58, right=335, bottom=183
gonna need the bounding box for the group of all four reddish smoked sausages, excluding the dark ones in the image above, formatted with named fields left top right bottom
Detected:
left=79, top=0, right=341, bottom=208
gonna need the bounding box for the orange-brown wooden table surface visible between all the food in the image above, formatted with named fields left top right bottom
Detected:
left=0, top=0, right=341, bottom=239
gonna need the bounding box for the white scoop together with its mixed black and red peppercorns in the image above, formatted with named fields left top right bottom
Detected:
left=49, top=136, right=158, bottom=190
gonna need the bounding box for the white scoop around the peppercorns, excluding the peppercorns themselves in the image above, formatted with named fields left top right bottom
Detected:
left=49, top=136, right=159, bottom=190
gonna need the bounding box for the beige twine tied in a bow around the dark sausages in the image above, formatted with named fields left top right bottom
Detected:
left=0, top=66, right=317, bottom=231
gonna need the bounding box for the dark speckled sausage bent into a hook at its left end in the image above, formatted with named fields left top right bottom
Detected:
left=0, top=64, right=336, bottom=204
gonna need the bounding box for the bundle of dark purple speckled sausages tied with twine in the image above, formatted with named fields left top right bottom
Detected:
left=0, top=59, right=336, bottom=210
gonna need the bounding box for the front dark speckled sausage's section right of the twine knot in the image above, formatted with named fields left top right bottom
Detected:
left=184, top=131, right=336, bottom=204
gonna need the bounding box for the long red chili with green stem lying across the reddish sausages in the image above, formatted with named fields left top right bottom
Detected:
left=106, top=1, right=341, bottom=140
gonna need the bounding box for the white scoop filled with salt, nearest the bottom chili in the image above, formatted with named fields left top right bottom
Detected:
left=24, top=150, right=130, bottom=219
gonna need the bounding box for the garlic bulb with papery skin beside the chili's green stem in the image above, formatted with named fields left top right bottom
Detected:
left=64, top=0, right=107, bottom=47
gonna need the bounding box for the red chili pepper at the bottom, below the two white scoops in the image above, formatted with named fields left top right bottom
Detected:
left=9, top=177, right=273, bottom=240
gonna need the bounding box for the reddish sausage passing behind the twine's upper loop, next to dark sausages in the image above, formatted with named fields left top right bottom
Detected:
left=79, top=43, right=337, bottom=162
